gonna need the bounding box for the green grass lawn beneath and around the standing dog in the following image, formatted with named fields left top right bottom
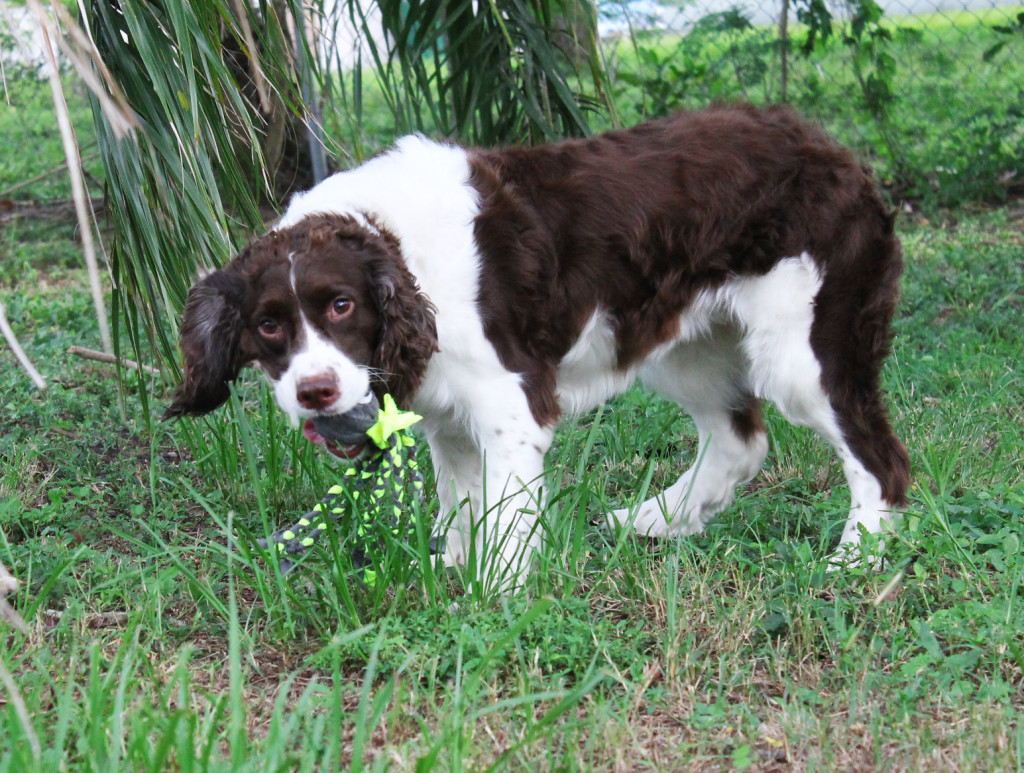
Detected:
left=0, top=61, right=1024, bottom=773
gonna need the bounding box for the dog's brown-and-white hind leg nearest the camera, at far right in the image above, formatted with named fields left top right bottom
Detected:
left=733, top=250, right=909, bottom=561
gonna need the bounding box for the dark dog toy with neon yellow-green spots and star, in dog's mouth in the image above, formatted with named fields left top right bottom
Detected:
left=257, top=392, right=440, bottom=587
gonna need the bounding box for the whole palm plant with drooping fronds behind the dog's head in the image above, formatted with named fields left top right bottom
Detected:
left=86, top=0, right=601, bottom=389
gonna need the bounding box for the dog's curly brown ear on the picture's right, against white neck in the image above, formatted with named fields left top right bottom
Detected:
left=366, top=250, right=437, bottom=404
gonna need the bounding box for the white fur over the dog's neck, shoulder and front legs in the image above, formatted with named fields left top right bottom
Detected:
left=278, top=136, right=552, bottom=587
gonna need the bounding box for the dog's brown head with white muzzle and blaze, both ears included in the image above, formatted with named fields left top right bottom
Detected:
left=166, top=215, right=437, bottom=444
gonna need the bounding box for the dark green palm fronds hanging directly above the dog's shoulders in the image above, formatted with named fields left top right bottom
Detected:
left=331, top=0, right=604, bottom=144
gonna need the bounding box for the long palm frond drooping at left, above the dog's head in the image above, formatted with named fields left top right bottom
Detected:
left=88, top=0, right=311, bottom=384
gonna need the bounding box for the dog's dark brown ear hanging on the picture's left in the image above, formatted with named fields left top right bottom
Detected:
left=164, top=269, right=252, bottom=419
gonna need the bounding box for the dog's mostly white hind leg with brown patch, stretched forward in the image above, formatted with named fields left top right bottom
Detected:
left=609, top=328, right=768, bottom=536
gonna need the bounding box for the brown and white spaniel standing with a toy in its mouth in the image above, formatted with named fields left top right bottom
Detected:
left=168, top=106, right=909, bottom=588
